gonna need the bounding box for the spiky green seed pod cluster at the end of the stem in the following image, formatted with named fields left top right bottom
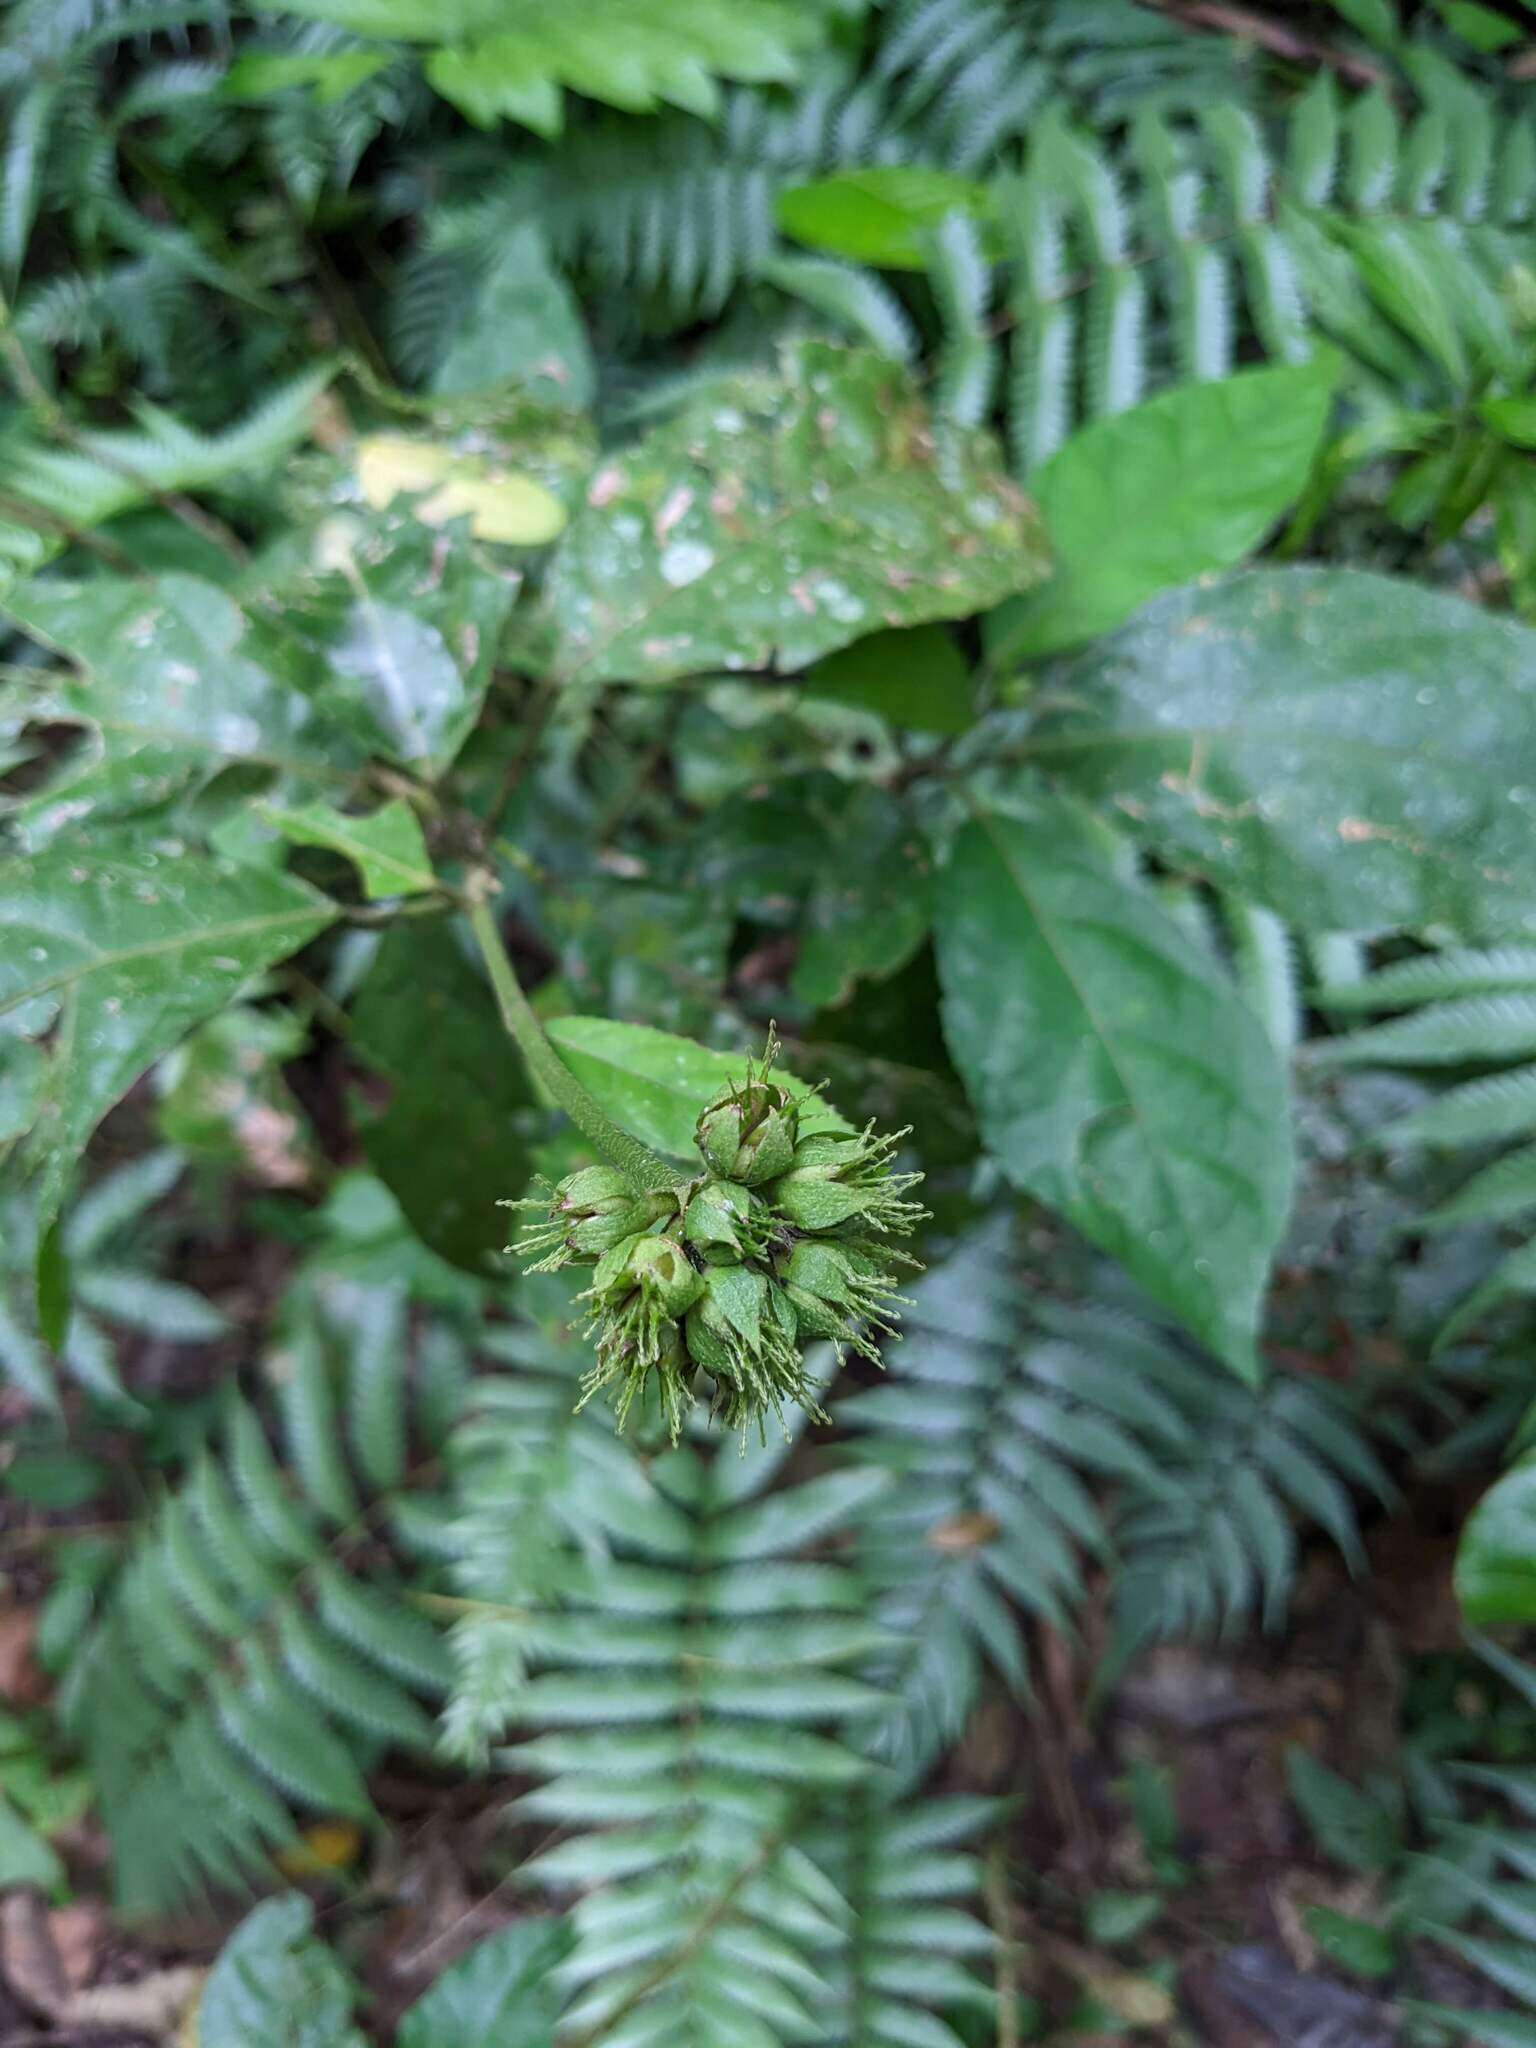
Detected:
left=510, top=1038, right=926, bottom=1442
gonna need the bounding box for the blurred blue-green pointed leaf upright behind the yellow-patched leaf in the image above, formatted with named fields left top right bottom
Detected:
left=432, top=221, right=596, bottom=411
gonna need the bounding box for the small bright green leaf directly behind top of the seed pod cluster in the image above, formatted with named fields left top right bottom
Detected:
left=545, top=1018, right=848, bottom=1159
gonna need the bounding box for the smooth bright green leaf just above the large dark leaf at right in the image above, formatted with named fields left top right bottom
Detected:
left=987, top=352, right=1339, bottom=662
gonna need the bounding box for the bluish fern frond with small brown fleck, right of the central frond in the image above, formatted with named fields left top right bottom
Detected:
left=838, top=1221, right=1184, bottom=1769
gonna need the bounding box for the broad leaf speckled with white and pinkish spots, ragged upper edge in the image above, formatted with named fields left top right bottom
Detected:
left=547, top=342, right=1044, bottom=682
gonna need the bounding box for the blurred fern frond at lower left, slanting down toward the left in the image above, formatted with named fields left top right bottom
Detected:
left=66, top=1276, right=457, bottom=1913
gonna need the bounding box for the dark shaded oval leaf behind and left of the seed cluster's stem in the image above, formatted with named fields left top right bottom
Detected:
left=352, top=920, right=539, bottom=1274
